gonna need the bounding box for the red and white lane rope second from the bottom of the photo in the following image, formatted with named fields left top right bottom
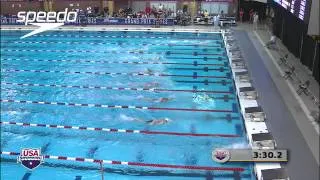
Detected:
left=0, top=121, right=239, bottom=138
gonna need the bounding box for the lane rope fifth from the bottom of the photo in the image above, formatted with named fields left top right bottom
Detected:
left=1, top=69, right=230, bottom=79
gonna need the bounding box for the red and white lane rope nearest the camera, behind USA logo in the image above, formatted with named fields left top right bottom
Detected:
left=1, top=151, right=245, bottom=172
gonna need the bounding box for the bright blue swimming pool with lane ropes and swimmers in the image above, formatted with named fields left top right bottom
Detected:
left=1, top=31, right=254, bottom=179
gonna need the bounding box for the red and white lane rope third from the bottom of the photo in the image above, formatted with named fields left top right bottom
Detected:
left=0, top=99, right=235, bottom=113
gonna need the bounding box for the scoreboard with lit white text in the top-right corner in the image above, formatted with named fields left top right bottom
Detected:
left=274, top=0, right=311, bottom=21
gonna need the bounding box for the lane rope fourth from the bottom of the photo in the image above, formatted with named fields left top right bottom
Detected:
left=1, top=82, right=233, bottom=94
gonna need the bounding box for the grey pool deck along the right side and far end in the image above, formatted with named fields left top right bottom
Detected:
left=1, top=24, right=319, bottom=180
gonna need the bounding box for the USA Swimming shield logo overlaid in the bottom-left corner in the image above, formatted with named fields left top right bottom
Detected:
left=17, top=148, right=44, bottom=170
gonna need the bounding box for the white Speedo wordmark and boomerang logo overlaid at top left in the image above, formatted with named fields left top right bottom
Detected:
left=17, top=8, right=78, bottom=39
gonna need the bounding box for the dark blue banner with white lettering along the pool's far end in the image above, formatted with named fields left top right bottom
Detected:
left=1, top=16, right=174, bottom=26
